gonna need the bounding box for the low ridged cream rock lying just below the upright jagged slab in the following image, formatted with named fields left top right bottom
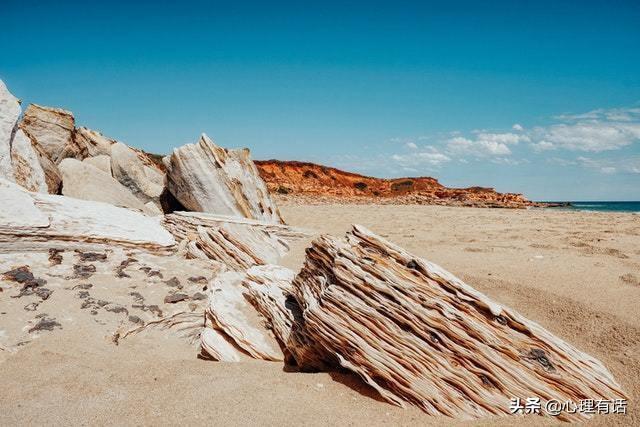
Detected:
left=164, top=212, right=307, bottom=270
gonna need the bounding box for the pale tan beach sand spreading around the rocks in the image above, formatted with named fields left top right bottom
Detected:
left=0, top=204, right=640, bottom=426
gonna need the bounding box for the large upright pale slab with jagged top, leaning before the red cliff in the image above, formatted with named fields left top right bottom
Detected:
left=164, top=134, right=283, bottom=223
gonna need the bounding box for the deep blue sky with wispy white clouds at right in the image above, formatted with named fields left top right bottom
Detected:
left=0, top=0, right=640, bottom=200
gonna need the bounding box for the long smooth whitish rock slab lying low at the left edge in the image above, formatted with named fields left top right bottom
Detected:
left=0, top=180, right=175, bottom=253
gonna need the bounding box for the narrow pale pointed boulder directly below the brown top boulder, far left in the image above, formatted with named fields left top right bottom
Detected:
left=11, top=129, right=49, bottom=193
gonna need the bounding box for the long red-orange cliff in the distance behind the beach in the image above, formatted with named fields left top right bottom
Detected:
left=255, top=160, right=533, bottom=208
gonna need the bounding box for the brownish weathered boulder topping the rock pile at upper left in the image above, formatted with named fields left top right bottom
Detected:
left=20, top=104, right=77, bottom=164
